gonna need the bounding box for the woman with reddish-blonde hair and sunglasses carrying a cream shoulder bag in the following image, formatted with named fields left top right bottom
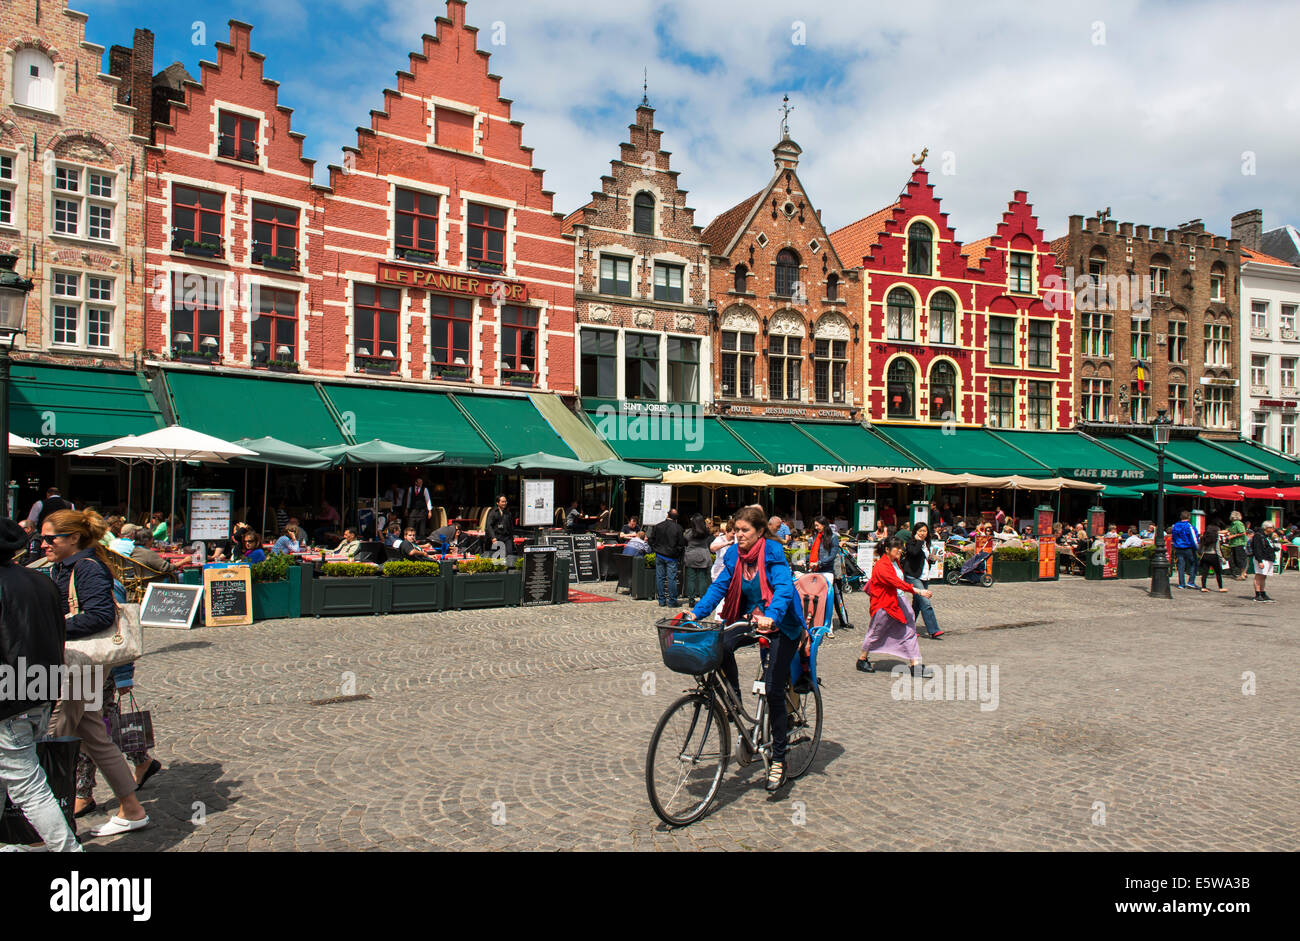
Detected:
left=40, top=509, right=150, bottom=837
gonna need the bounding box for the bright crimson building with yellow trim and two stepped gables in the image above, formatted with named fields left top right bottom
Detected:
left=831, top=166, right=1074, bottom=430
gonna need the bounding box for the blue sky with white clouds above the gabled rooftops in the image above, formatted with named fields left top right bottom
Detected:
left=73, top=0, right=1300, bottom=242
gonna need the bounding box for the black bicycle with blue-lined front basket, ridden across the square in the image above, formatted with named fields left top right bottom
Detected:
left=646, top=619, right=822, bottom=827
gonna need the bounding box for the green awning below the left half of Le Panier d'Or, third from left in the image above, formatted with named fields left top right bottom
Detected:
left=324, top=383, right=501, bottom=467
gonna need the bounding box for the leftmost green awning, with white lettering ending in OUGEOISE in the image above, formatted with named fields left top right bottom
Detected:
left=9, top=363, right=165, bottom=451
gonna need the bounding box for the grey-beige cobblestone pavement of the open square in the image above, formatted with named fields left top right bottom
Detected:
left=79, top=573, right=1300, bottom=851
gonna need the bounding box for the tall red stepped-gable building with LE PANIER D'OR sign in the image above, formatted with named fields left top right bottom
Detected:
left=320, top=0, right=575, bottom=394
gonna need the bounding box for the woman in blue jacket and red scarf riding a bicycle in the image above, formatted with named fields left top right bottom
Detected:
left=690, top=507, right=810, bottom=790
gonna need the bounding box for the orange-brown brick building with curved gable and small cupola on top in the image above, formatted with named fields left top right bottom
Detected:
left=703, top=133, right=862, bottom=421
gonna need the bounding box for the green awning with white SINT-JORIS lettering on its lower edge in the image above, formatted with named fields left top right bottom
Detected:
left=588, top=408, right=767, bottom=474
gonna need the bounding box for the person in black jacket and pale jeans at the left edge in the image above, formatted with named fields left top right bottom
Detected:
left=0, top=520, right=81, bottom=853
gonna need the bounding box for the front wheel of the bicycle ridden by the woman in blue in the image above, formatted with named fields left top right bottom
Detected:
left=646, top=693, right=731, bottom=827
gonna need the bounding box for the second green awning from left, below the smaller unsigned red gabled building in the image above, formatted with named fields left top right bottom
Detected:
left=163, top=369, right=347, bottom=447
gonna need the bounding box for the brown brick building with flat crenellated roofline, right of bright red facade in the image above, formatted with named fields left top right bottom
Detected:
left=1052, top=216, right=1242, bottom=437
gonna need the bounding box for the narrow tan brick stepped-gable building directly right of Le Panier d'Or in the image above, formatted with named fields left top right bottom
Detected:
left=564, top=101, right=712, bottom=408
